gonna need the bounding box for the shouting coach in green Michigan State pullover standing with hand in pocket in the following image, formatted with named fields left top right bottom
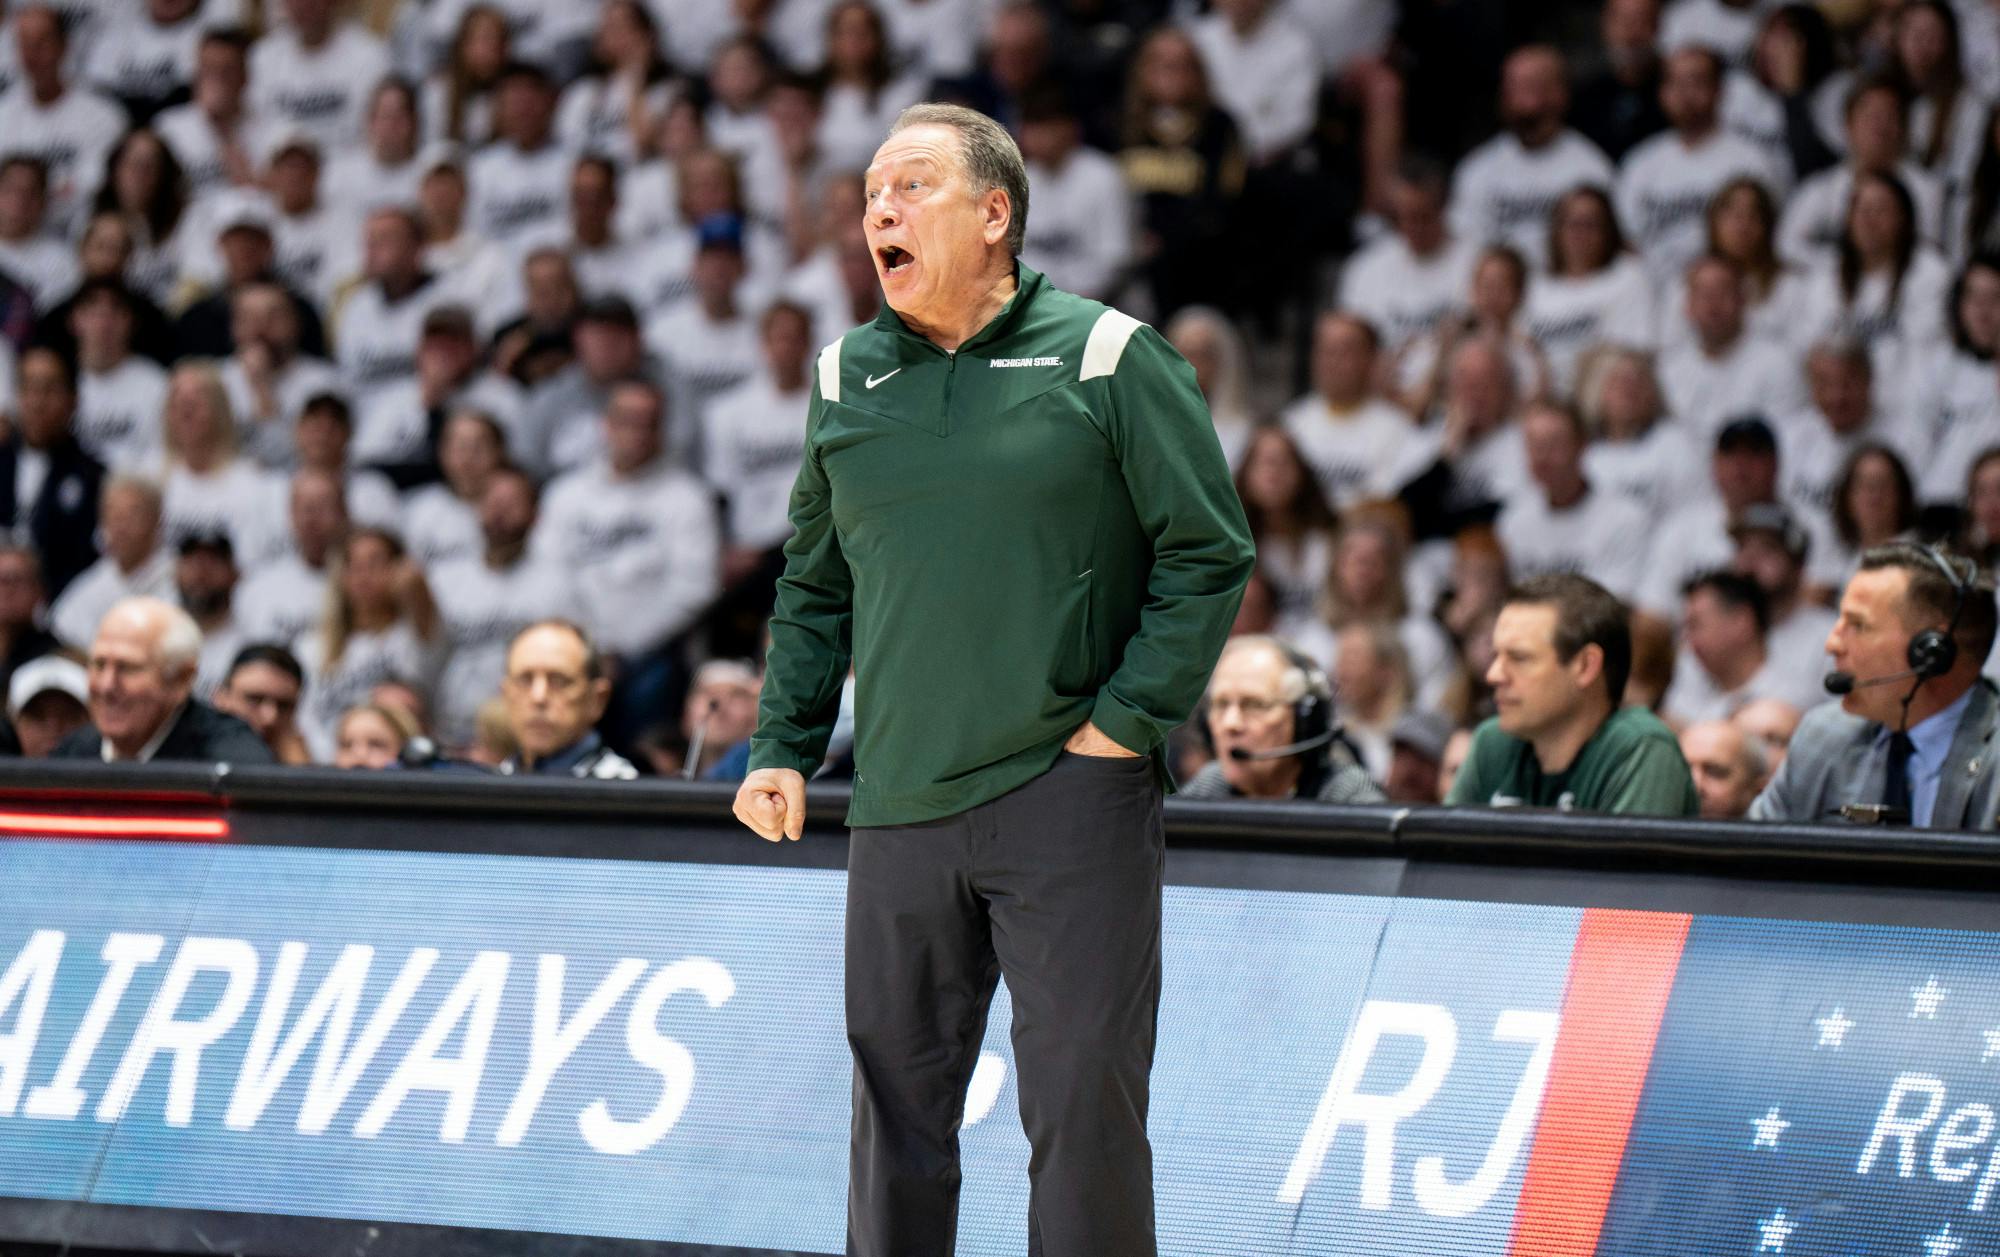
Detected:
left=736, top=104, right=1254, bottom=1257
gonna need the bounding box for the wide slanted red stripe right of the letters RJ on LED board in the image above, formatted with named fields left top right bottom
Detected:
left=1508, top=909, right=1694, bottom=1257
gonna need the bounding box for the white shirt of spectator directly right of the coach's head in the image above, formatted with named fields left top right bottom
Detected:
left=1022, top=148, right=1132, bottom=300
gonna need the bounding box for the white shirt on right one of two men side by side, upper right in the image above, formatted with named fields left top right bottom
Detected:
left=1618, top=130, right=1786, bottom=280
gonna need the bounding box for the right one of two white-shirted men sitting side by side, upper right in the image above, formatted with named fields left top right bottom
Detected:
left=1618, top=46, right=1790, bottom=282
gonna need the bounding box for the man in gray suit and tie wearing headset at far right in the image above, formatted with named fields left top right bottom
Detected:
left=1750, top=542, right=2000, bottom=829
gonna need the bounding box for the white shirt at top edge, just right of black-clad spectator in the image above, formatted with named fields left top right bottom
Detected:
left=1184, top=12, right=1320, bottom=159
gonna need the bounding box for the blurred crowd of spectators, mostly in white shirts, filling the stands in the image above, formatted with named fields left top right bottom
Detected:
left=0, top=0, right=2000, bottom=815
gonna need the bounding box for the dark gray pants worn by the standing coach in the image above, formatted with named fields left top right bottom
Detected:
left=846, top=751, right=1166, bottom=1257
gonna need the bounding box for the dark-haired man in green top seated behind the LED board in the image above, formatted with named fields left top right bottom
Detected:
left=1446, top=572, right=1700, bottom=817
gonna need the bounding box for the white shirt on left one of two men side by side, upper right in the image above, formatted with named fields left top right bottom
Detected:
left=1450, top=130, right=1614, bottom=268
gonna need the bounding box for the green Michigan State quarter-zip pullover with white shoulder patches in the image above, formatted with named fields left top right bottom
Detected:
left=750, top=266, right=1256, bottom=827
